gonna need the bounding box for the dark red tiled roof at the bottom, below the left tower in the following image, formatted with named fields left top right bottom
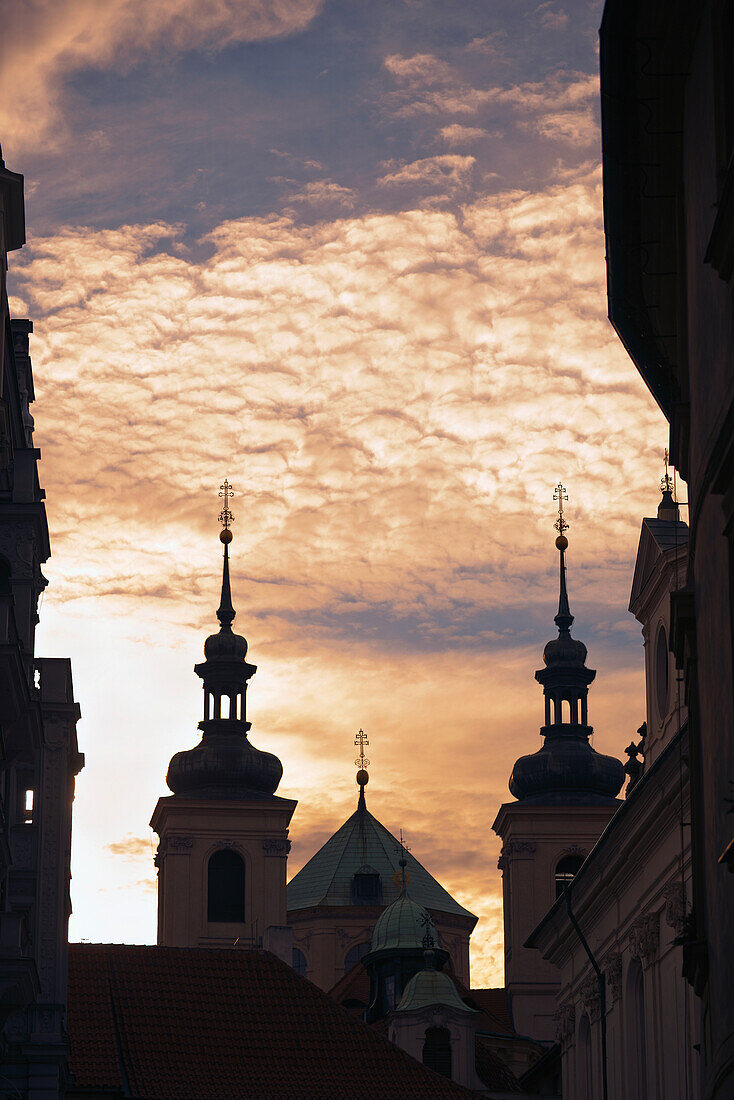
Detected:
left=68, top=944, right=472, bottom=1100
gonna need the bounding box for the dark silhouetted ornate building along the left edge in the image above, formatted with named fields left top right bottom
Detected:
left=0, top=155, right=84, bottom=1100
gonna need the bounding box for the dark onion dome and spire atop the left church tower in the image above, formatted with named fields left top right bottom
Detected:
left=166, top=480, right=283, bottom=799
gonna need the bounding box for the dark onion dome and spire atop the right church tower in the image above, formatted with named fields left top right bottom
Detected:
left=510, top=482, right=624, bottom=805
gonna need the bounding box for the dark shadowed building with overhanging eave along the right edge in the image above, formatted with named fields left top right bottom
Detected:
left=601, top=0, right=734, bottom=1098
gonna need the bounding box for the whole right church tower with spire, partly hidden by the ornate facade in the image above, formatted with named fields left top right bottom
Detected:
left=492, top=484, right=625, bottom=1040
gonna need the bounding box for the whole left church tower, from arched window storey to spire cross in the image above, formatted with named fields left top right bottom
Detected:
left=151, top=481, right=296, bottom=964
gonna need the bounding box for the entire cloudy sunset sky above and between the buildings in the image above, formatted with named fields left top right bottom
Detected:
left=0, top=0, right=667, bottom=986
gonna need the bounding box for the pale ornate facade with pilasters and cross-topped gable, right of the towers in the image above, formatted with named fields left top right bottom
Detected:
left=528, top=488, right=701, bottom=1100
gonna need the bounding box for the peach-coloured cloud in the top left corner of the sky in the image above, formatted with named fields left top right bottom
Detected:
left=0, top=0, right=324, bottom=151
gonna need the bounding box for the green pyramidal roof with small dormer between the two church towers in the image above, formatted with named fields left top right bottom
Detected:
left=287, top=799, right=476, bottom=922
